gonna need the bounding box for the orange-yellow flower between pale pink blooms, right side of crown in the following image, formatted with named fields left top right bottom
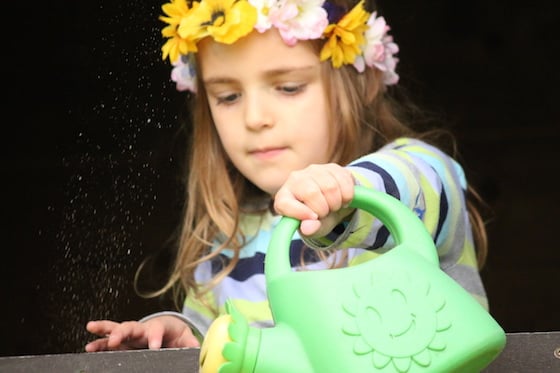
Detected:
left=320, top=0, right=369, bottom=68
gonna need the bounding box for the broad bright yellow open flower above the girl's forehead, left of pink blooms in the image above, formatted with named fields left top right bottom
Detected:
left=178, top=0, right=257, bottom=44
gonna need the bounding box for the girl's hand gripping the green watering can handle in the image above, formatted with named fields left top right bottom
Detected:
left=274, top=163, right=354, bottom=237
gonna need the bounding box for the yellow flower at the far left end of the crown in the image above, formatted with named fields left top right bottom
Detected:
left=159, top=0, right=197, bottom=63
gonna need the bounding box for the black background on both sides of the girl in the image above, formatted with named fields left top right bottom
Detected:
left=0, top=0, right=560, bottom=356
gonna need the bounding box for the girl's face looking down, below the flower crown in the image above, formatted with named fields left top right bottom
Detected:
left=198, top=29, right=330, bottom=196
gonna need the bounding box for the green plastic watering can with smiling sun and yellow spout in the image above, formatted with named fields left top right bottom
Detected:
left=200, top=186, right=506, bottom=373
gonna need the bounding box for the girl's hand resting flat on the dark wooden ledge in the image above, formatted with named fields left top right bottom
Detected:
left=85, top=316, right=200, bottom=352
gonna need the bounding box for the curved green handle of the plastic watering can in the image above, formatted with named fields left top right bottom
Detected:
left=265, top=185, right=439, bottom=280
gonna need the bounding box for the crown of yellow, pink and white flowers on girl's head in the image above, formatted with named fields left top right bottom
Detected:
left=159, top=0, right=399, bottom=92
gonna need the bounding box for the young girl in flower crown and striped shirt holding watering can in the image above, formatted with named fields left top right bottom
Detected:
left=86, top=0, right=487, bottom=351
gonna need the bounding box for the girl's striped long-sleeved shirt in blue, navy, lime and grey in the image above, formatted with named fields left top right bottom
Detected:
left=181, top=138, right=488, bottom=335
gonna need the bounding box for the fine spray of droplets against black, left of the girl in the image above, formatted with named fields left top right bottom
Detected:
left=41, top=1, right=186, bottom=352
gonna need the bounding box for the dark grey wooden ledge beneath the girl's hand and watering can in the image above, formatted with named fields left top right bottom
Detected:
left=0, top=331, right=560, bottom=373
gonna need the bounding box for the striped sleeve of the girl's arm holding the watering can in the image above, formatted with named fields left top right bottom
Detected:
left=305, top=138, right=466, bottom=255
